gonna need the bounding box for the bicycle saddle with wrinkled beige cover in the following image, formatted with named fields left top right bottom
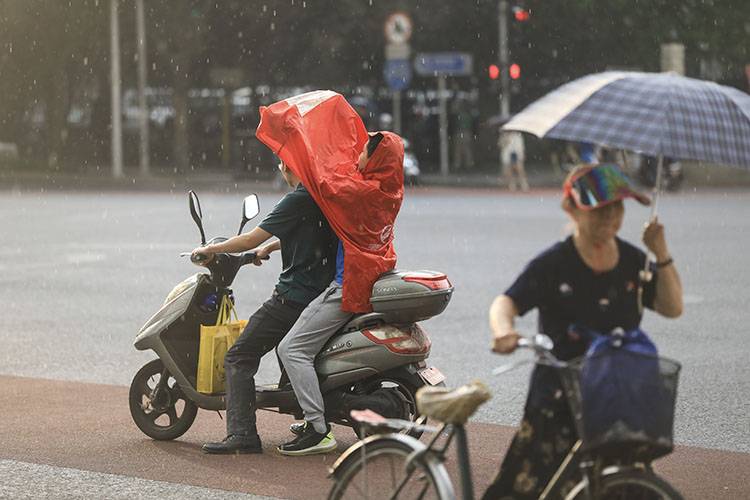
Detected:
left=417, top=380, right=492, bottom=425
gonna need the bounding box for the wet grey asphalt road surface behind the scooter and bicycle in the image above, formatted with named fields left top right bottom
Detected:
left=0, top=189, right=750, bottom=498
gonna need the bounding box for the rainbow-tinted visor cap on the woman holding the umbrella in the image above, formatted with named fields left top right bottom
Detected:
left=563, top=164, right=651, bottom=210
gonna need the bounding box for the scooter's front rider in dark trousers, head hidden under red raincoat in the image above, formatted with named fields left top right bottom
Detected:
left=193, top=162, right=337, bottom=454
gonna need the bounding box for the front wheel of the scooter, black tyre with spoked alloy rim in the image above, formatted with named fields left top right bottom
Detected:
left=129, top=359, right=198, bottom=441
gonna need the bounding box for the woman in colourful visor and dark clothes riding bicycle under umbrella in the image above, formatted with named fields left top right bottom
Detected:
left=484, top=164, right=682, bottom=499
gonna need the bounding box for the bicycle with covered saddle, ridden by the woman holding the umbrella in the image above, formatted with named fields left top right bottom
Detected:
left=328, top=335, right=682, bottom=500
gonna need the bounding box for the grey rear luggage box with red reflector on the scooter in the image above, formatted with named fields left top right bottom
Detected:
left=370, top=270, right=453, bottom=324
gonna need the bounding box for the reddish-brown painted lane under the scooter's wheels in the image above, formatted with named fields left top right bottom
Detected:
left=0, top=376, right=750, bottom=499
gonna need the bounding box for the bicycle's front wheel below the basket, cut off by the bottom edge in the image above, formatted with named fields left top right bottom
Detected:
left=566, top=470, right=682, bottom=500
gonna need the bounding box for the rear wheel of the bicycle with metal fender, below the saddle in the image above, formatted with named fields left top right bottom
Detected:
left=328, top=435, right=455, bottom=500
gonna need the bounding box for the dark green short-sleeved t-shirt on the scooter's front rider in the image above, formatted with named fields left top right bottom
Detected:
left=258, top=184, right=338, bottom=305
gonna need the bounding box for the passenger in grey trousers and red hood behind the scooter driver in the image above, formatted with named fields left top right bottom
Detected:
left=278, top=132, right=403, bottom=456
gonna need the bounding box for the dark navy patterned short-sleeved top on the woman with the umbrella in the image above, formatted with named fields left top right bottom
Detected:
left=505, top=237, right=656, bottom=360
